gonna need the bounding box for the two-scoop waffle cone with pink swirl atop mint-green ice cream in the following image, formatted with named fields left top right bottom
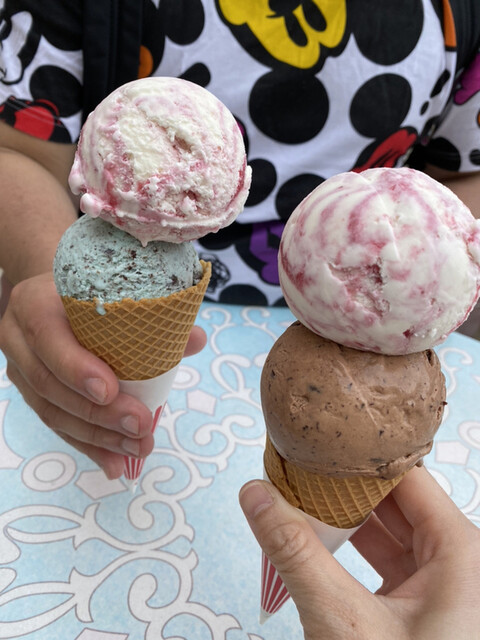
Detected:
left=54, top=76, right=252, bottom=484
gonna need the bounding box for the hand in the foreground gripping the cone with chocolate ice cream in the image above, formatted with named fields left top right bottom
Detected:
left=240, top=467, right=480, bottom=640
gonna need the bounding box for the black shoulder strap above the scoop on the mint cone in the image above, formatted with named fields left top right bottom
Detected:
left=83, top=0, right=143, bottom=121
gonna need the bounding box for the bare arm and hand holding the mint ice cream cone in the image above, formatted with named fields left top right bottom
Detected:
left=0, top=123, right=205, bottom=478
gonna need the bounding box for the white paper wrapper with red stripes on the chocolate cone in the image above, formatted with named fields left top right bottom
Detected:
left=260, top=469, right=363, bottom=623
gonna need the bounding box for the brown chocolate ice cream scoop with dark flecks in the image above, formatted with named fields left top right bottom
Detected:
left=261, top=322, right=446, bottom=479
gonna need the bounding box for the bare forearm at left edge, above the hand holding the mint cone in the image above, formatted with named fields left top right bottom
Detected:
left=0, top=122, right=76, bottom=284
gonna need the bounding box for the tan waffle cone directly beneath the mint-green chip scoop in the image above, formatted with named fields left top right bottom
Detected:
left=62, top=260, right=211, bottom=380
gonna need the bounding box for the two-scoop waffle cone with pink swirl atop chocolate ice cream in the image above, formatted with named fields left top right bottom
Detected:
left=255, top=167, right=480, bottom=624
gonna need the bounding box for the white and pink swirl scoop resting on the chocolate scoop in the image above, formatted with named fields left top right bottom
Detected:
left=279, top=168, right=480, bottom=355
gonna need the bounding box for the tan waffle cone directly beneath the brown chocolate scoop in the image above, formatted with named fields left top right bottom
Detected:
left=264, top=435, right=403, bottom=529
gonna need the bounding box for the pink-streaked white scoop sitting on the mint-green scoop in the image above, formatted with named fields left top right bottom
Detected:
left=69, top=77, right=251, bottom=245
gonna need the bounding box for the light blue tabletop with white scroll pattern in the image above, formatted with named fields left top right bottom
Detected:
left=0, top=303, right=480, bottom=640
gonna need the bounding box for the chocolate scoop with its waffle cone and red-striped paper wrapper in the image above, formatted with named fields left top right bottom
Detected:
left=261, top=322, right=445, bottom=619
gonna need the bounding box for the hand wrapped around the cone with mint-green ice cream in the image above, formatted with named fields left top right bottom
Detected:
left=0, top=274, right=205, bottom=479
